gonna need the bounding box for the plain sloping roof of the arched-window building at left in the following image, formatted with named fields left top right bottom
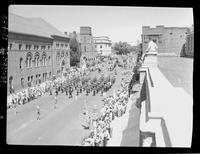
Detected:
left=8, top=13, right=67, bottom=38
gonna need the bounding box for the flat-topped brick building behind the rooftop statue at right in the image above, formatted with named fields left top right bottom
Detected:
left=142, top=25, right=188, bottom=56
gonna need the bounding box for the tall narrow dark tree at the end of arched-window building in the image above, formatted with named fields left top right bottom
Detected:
left=69, top=32, right=81, bottom=66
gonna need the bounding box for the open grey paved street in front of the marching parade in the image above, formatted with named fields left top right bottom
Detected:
left=7, top=65, right=123, bottom=145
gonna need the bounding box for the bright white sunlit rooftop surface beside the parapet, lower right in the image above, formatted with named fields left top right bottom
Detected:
left=140, top=56, right=193, bottom=147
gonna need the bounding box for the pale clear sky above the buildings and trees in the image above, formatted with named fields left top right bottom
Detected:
left=9, top=5, right=193, bottom=45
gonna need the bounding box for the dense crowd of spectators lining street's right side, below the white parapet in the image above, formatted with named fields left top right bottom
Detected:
left=81, top=69, right=132, bottom=146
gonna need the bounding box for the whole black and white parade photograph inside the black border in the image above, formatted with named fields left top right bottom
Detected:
left=6, top=4, right=194, bottom=148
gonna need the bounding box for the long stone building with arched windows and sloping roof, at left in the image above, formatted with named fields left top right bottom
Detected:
left=7, top=13, right=70, bottom=93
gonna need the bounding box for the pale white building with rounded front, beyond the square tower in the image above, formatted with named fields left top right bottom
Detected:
left=93, top=36, right=112, bottom=56
